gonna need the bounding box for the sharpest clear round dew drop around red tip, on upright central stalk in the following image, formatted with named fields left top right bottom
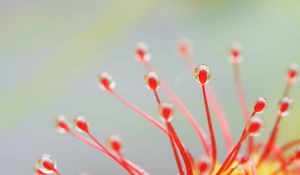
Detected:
left=194, top=64, right=211, bottom=86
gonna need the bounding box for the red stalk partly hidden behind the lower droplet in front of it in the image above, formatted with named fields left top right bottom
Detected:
left=153, top=90, right=184, bottom=175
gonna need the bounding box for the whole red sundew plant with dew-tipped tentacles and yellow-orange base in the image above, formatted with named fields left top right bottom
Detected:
left=34, top=39, right=300, bottom=175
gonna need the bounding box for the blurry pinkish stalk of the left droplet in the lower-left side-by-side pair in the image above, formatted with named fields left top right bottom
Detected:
left=69, top=131, right=149, bottom=174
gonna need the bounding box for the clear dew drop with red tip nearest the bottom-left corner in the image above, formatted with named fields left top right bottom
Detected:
left=38, top=154, right=57, bottom=174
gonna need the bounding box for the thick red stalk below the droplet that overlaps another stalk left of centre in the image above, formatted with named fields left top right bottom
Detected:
left=166, top=121, right=193, bottom=175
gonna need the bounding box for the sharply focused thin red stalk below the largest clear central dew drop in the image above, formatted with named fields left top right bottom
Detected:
left=202, top=85, right=217, bottom=173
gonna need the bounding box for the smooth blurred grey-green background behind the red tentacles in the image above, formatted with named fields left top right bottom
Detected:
left=0, top=0, right=300, bottom=175
